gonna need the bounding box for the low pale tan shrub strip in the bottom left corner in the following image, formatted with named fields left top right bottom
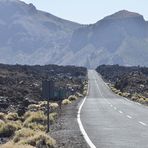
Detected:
left=1, top=142, right=35, bottom=148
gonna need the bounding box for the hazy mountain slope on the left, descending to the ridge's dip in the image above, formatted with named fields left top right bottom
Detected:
left=0, top=0, right=81, bottom=64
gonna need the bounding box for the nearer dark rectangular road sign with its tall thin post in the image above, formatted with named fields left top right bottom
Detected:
left=42, top=80, right=54, bottom=133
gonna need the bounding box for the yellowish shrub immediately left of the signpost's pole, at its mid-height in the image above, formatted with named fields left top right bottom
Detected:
left=24, top=111, right=46, bottom=127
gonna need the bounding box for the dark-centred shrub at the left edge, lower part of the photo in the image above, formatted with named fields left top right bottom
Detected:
left=0, top=122, right=21, bottom=137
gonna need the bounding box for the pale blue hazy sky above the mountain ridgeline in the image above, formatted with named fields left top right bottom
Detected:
left=23, top=0, right=148, bottom=24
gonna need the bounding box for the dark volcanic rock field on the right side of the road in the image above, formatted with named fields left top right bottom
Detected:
left=96, top=65, right=148, bottom=97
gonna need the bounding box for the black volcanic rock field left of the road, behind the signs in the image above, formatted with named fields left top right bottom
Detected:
left=0, top=64, right=87, bottom=112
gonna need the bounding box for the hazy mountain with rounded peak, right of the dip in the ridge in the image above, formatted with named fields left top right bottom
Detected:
left=63, top=10, right=148, bottom=68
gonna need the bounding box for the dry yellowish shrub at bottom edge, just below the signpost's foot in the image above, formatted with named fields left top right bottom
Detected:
left=19, top=132, right=56, bottom=148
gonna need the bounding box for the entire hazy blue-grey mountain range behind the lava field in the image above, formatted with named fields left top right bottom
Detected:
left=0, top=0, right=148, bottom=68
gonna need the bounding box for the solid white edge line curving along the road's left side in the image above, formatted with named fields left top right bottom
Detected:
left=77, top=80, right=96, bottom=148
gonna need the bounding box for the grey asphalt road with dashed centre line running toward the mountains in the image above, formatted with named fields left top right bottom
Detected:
left=80, top=70, right=148, bottom=148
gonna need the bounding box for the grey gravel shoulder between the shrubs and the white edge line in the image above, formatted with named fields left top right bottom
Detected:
left=50, top=99, right=89, bottom=148
